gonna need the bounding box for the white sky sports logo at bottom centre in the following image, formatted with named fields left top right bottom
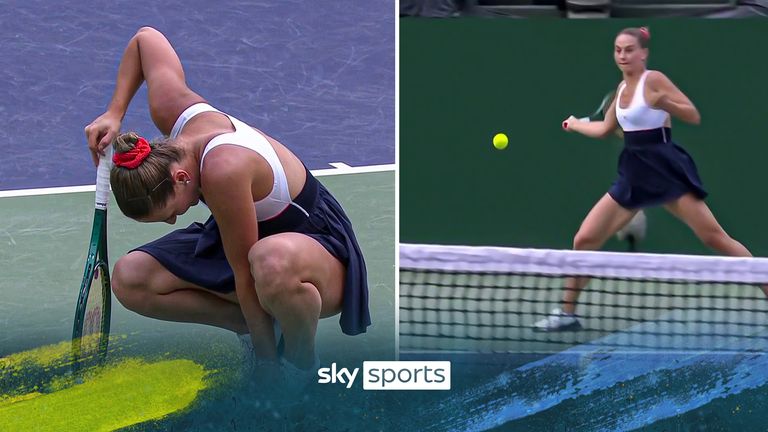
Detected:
left=317, top=361, right=451, bottom=390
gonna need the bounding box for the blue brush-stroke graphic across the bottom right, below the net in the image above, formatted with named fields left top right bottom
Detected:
left=400, top=324, right=768, bottom=431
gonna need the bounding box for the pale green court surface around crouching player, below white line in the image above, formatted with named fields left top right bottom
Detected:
left=0, top=171, right=395, bottom=363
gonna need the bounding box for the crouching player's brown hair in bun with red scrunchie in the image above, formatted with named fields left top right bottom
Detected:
left=109, top=132, right=183, bottom=219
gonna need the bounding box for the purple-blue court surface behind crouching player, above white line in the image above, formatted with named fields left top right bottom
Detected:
left=0, top=0, right=395, bottom=190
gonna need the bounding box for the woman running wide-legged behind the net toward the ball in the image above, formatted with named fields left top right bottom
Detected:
left=534, top=27, right=768, bottom=331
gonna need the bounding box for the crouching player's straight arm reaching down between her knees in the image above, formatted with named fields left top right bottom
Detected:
left=201, top=149, right=277, bottom=359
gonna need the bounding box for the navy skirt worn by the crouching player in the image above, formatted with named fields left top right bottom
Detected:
left=134, top=170, right=371, bottom=335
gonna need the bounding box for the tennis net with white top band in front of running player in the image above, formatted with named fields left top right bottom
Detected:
left=399, top=244, right=768, bottom=353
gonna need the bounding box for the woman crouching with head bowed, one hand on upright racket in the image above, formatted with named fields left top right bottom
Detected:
left=85, top=27, right=370, bottom=370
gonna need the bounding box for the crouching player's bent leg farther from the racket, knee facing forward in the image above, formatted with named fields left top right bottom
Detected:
left=248, top=233, right=345, bottom=368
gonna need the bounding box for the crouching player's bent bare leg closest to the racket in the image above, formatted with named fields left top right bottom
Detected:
left=112, top=251, right=248, bottom=334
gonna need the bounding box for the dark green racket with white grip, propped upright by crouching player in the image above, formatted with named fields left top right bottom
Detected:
left=72, top=146, right=112, bottom=371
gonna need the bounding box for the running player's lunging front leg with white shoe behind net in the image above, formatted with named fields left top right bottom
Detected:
left=533, top=193, right=637, bottom=331
